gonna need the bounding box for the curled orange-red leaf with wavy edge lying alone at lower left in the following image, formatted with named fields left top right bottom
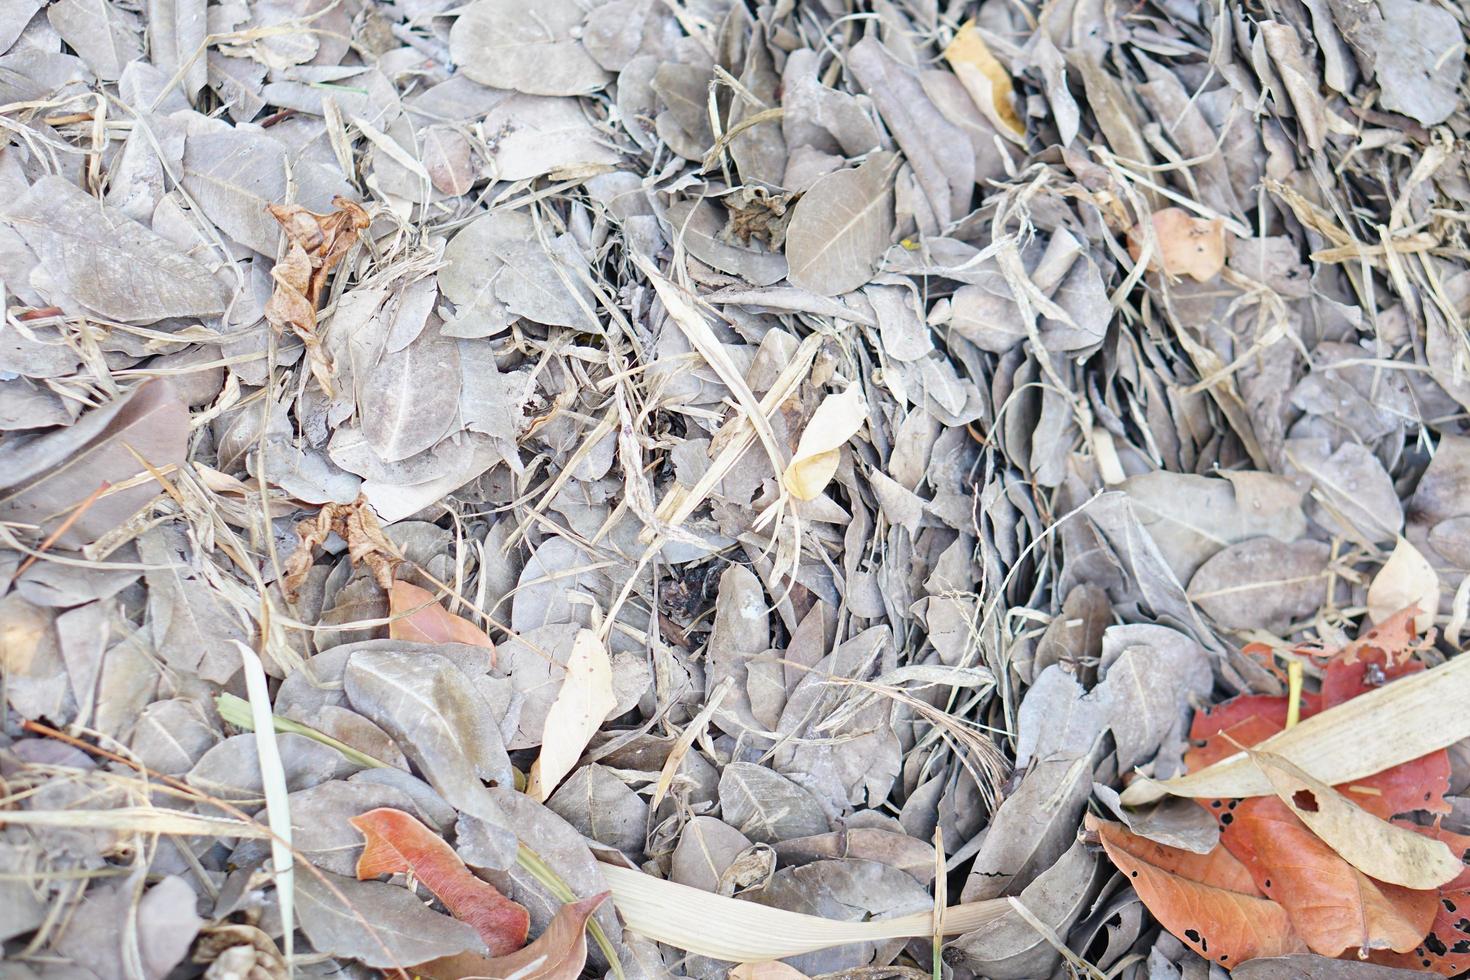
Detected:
left=350, top=807, right=531, bottom=956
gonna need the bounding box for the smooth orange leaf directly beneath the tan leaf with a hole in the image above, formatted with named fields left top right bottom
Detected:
left=1220, top=796, right=1438, bottom=956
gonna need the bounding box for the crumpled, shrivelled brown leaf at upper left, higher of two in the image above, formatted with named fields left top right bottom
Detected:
left=266, top=197, right=370, bottom=395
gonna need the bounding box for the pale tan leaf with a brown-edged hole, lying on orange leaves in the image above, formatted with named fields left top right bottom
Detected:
left=1251, top=752, right=1464, bottom=889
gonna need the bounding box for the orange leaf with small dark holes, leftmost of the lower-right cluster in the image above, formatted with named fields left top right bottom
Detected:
left=1086, top=814, right=1307, bottom=968
